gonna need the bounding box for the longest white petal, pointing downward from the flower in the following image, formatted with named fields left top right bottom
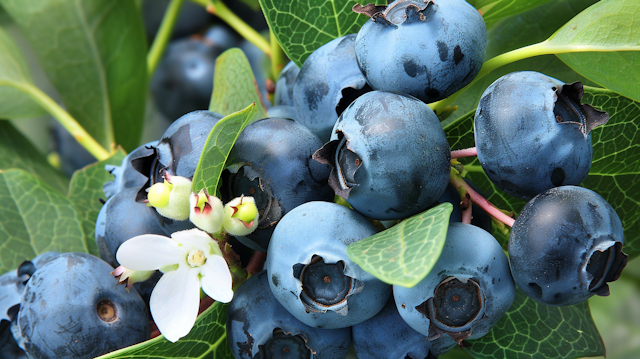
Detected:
left=149, top=265, right=200, bottom=343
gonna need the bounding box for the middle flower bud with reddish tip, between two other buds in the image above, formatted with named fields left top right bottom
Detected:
left=189, top=189, right=224, bottom=233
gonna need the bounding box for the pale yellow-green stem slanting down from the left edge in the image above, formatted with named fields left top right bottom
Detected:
left=0, top=80, right=110, bottom=161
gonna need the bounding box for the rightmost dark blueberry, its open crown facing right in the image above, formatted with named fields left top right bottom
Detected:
left=509, top=186, right=627, bottom=306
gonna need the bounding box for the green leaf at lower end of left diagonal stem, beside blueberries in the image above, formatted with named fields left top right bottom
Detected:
left=69, top=149, right=125, bottom=257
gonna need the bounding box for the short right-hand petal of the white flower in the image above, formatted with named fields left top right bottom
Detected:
left=200, top=255, right=233, bottom=303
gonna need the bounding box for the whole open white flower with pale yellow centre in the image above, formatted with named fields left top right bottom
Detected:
left=116, top=229, right=233, bottom=342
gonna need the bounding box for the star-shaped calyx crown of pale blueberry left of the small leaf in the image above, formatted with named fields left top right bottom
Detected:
left=293, top=255, right=364, bottom=316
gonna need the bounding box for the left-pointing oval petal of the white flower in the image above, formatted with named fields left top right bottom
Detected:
left=116, top=234, right=187, bottom=271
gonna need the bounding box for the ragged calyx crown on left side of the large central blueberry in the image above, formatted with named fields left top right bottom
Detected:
left=312, top=132, right=362, bottom=199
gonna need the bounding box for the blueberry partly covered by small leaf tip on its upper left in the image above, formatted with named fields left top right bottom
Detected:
left=393, top=223, right=516, bottom=343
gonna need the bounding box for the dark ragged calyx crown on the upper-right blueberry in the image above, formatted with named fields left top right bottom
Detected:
left=553, top=82, right=609, bottom=136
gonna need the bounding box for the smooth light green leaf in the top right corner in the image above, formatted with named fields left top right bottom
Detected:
left=548, top=0, right=640, bottom=101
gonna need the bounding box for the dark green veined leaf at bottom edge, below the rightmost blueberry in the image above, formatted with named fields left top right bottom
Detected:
left=465, top=289, right=604, bottom=359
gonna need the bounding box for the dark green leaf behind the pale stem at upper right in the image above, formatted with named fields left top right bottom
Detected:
left=444, top=0, right=597, bottom=128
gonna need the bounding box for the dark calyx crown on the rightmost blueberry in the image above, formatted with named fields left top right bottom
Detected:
left=586, top=242, right=628, bottom=297
